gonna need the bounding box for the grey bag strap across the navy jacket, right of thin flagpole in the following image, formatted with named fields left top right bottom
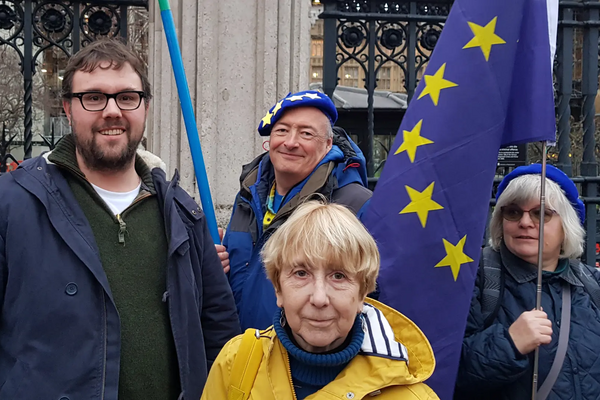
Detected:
left=536, top=282, right=571, bottom=400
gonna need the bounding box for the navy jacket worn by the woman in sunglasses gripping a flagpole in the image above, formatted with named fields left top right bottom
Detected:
left=454, top=247, right=600, bottom=400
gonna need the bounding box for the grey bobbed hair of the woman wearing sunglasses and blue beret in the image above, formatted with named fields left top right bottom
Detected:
left=490, top=175, right=585, bottom=258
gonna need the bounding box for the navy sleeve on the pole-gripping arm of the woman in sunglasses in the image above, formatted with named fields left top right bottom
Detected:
left=456, top=273, right=529, bottom=393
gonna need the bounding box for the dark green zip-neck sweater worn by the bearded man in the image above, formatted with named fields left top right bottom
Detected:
left=48, top=135, right=180, bottom=400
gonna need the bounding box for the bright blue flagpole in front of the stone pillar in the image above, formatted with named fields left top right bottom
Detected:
left=158, top=0, right=221, bottom=244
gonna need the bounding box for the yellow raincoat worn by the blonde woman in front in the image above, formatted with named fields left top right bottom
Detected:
left=202, top=299, right=438, bottom=400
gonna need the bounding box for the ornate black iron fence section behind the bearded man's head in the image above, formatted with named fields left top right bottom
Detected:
left=0, top=0, right=148, bottom=174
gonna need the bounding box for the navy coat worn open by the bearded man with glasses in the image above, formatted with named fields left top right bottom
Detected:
left=0, top=157, right=240, bottom=400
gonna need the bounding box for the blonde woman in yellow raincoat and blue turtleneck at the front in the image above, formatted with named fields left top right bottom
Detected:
left=202, top=201, right=438, bottom=400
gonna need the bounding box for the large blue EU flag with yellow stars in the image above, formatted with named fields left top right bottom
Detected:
left=364, top=0, right=558, bottom=399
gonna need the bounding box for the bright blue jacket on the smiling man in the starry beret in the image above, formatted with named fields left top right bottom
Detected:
left=223, top=127, right=372, bottom=329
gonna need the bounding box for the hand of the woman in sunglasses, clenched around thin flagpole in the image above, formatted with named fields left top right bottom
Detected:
left=508, top=310, right=552, bottom=355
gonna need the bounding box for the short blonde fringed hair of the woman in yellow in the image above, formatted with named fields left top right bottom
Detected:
left=261, top=200, right=379, bottom=296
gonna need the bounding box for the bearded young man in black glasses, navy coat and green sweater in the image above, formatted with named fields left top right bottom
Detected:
left=0, top=40, right=239, bottom=400
